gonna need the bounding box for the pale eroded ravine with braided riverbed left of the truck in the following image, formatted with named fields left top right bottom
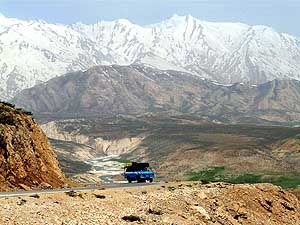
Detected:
left=42, top=122, right=145, bottom=183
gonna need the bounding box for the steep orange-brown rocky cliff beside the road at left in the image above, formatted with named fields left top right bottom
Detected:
left=0, top=103, right=66, bottom=191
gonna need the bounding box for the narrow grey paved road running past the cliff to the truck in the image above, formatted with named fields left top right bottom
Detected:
left=0, top=183, right=157, bottom=198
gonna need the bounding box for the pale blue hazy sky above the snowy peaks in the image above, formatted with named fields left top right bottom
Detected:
left=0, top=0, right=300, bottom=36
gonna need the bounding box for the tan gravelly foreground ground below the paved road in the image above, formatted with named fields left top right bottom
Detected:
left=0, top=183, right=300, bottom=225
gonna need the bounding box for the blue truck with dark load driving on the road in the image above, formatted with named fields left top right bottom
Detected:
left=124, top=162, right=154, bottom=183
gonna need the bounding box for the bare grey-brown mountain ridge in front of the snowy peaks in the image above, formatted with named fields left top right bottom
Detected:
left=14, top=65, right=300, bottom=122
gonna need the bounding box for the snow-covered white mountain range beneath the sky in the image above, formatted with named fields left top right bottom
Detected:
left=0, top=14, right=300, bottom=99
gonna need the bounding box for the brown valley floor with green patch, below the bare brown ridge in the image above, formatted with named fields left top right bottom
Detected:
left=35, top=115, right=300, bottom=187
